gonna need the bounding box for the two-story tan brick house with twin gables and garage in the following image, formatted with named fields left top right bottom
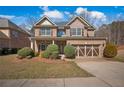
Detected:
left=31, top=16, right=106, bottom=57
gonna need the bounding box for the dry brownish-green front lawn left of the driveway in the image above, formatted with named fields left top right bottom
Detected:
left=0, top=55, right=92, bottom=79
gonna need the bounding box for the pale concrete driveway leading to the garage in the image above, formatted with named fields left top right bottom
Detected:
left=76, top=59, right=124, bottom=87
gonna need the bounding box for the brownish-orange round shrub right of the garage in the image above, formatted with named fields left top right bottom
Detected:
left=103, top=43, right=117, bottom=58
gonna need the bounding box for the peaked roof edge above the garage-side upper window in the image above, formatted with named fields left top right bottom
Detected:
left=66, top=16, right=95, bottom=29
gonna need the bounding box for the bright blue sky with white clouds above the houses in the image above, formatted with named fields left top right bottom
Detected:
left=0, top=6, right=124, bottom=26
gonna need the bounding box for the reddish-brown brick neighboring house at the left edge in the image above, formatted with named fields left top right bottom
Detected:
left=0, top=18, right=30, bottom=52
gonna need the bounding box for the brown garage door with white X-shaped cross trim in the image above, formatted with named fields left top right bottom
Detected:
left=75, top=45, right=99, bottom=57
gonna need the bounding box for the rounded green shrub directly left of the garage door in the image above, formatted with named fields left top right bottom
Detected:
left=64, top=45, right=75, bottom=58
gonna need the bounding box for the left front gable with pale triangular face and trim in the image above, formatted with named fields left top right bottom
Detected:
left=34, top=16, right=56, bottom=26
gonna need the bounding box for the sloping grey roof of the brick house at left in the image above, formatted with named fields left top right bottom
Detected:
left=0, top=18, right=30, bottom=35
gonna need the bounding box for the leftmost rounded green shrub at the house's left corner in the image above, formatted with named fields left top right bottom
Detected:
left=17, top=47, right=34, bottom=58
